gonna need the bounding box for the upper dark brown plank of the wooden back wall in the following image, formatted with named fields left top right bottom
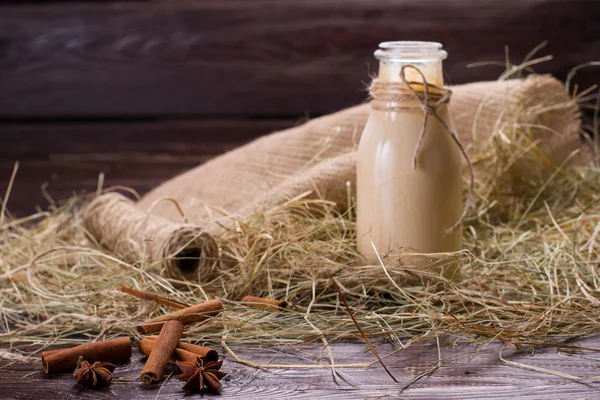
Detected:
left=0, top=0, right=600, bottom=118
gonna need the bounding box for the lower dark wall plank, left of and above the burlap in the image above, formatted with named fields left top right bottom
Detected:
left=0, top=119, right=292, bottom=215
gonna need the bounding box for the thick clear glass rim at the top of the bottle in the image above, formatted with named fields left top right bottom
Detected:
left=375, top=41, right=448, bottom=62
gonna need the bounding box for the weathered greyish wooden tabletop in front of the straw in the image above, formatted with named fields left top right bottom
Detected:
left=0, top=337, right=600, bottom=400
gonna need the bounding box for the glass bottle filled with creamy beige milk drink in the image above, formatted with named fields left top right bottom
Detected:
left=356, top=42, right=463, bottom=276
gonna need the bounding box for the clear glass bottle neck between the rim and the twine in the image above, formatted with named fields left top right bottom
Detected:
left=378, top=59, right=444, bottom=87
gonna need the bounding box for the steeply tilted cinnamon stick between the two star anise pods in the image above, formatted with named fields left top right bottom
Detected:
left=140, top=321, right=183, bottom=384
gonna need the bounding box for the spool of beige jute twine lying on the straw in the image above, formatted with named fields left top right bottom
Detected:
left=83, top=193, right=219, bottom=281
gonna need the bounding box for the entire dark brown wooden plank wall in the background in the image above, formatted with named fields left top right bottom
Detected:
left=0, top=0, right=600, bottom=216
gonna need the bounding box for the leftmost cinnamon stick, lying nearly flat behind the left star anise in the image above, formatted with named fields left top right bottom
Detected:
left=42, top=337, right=131, bottom=374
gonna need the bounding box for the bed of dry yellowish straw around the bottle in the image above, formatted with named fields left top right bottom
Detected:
left=0, top=57, right=600, bottom=368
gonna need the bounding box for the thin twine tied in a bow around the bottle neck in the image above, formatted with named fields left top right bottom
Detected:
left=369, top=64, right=475, bottom=233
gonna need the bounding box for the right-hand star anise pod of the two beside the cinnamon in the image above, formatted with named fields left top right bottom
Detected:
left=175, top=357, right=227, bottom=392
